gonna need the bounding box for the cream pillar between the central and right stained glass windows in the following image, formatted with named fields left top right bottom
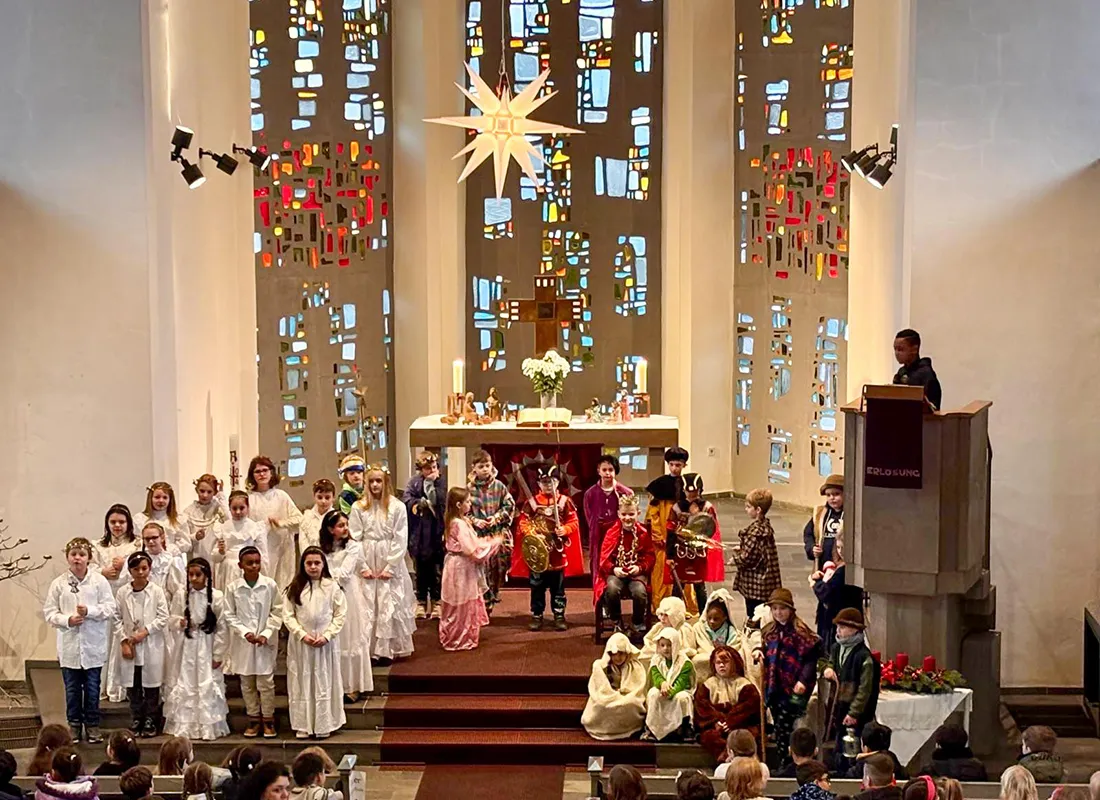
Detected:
left=661, top=0, right=736, bottom=492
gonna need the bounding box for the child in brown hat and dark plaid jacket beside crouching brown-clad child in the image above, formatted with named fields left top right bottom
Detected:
left=761, top=589, right=821, bottom=763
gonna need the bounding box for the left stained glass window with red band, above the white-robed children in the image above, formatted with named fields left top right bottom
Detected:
left=249, top=0, right=393, bottom=501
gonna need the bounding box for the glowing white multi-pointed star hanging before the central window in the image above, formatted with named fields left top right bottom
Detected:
left=425, top=64, right=584, bottom=198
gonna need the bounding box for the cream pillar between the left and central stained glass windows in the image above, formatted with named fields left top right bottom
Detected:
left=393, top=0, right=469, bottom=484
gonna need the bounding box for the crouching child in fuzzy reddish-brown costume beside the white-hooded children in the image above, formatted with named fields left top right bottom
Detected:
left=695, top=645, right=760, bottom=760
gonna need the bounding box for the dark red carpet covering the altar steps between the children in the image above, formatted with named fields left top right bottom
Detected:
left=382, top=589, right=657, bottom=765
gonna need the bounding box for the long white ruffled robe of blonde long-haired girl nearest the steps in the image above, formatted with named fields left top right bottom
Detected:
left=349, top=497, right=416, bottom=658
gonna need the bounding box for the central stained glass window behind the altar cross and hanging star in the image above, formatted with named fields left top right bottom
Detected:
left=465, top=0, right=663, bottom=413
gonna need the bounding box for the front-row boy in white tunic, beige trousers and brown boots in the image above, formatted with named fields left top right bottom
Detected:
left=226, top=545, right=283, bottom=738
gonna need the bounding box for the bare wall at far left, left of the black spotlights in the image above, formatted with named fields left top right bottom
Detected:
left=0, top=0, right=153, bottom=679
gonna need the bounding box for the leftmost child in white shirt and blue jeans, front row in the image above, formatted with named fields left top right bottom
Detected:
left=42, top=539, right=116, bottom=744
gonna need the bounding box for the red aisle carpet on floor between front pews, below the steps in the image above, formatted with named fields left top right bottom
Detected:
left=416, top=764, right=565, bottom=800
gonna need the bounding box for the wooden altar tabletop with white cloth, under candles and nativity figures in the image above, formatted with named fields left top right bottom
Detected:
left=409, top=414, right=680, bottom=480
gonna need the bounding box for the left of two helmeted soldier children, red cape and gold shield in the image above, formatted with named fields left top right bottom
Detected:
left=512, top=463, right=584, bottom=631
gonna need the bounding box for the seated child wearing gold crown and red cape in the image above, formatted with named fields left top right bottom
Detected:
left=592, top=494, right=656, bottom=637
